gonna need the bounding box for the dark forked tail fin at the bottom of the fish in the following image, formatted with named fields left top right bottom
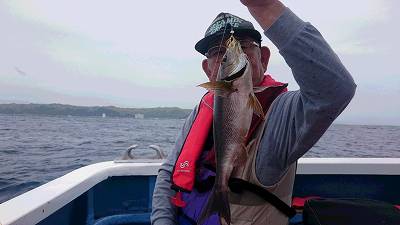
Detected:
left=197, top=187, right=231, bottom=224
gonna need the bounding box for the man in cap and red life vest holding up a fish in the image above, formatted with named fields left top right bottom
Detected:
left=151, top=0, right=356, bottom=225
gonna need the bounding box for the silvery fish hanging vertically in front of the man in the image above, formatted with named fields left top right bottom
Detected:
left=198, top=35, right=264, bottom=224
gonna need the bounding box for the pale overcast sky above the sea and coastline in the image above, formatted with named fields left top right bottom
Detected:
left=0, top=0, right=400, bottom=125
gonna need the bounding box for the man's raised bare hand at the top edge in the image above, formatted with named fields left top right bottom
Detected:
left=240, top=0, right=285, bottom=30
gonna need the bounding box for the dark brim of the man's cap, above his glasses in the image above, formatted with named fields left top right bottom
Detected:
left=194, top=29, right=261, bottom=55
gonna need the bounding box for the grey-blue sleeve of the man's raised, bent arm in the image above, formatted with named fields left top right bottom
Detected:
left=256, top=8, right=356, bottom=185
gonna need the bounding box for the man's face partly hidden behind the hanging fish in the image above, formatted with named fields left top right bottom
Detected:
left=203, top=38, right=269, bottom=86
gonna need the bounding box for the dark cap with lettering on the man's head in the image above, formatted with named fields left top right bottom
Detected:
left=194, top=13, right=261, bottom=55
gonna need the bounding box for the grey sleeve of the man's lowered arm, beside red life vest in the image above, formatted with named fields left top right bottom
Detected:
left=150, top=107, right=197, bottom=225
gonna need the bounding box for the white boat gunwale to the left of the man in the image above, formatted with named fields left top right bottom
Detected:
left=0, top=161, right=161, bottom=225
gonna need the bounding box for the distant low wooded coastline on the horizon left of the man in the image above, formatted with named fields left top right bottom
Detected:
left=0, top=103, right=191, bottom=119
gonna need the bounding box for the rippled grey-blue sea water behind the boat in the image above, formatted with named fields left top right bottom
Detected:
left=0, top=114, right=400, bottom=203
